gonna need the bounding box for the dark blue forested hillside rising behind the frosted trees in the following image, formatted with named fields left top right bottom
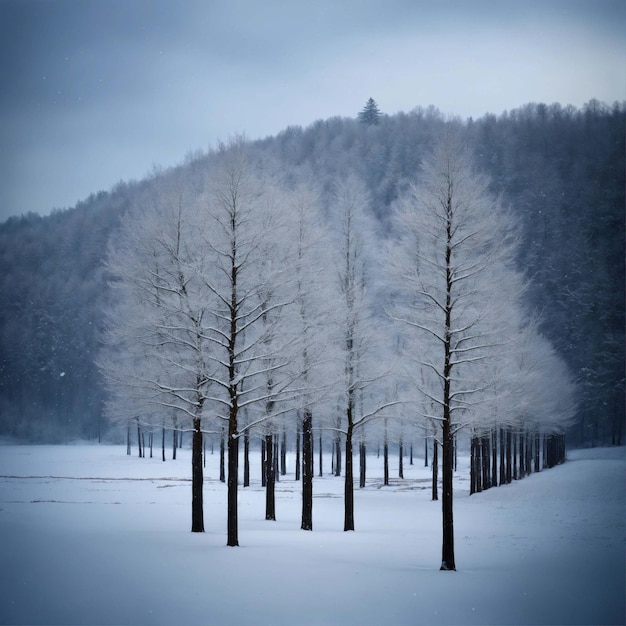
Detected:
left=0, top=101, right=626, bottom=444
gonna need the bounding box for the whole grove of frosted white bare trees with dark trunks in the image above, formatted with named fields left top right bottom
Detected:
left=99, top=129, right=575, bottom=570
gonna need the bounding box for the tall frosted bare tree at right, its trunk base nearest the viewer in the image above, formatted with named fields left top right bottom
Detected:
left=389, top=126, right=519, bottom=570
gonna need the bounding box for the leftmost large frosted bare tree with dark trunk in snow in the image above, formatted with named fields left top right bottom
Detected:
left=99, top=168, right=210, bottom=532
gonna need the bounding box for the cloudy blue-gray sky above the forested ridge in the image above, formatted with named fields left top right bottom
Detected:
left=0, top=0, right=626, bottom=221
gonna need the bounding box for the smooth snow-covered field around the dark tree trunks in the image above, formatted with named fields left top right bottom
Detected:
left=0, top=444, right=626, bottom=626
